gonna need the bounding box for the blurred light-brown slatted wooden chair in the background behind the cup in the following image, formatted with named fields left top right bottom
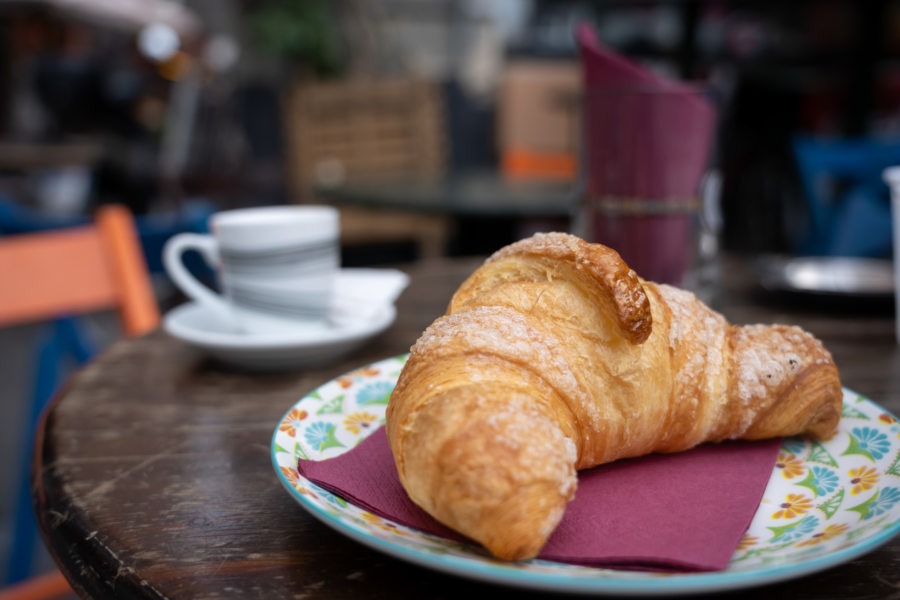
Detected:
left=283, top=78, right=452, bottom=258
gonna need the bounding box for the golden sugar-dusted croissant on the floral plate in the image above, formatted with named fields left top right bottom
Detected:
left=386, top=233, right=842, bottom=560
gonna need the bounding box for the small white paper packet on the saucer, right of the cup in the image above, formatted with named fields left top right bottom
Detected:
left=331, top=268, right=409, bottom=320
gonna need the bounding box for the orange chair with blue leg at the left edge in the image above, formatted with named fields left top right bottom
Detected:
left=0, top=205, right=160, bottom=600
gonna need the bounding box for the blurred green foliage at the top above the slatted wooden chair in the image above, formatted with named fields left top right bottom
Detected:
left=251, top=0, right=343, bottom=76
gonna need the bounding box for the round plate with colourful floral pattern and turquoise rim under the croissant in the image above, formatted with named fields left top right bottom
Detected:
left=271, top=355, right=900, bottom=595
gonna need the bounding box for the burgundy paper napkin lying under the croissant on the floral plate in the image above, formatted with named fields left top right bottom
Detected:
left=298, top=427, right=780, bottom=571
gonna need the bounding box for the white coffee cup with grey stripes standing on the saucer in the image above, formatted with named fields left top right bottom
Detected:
left=163, top=205, right=340, bottom=334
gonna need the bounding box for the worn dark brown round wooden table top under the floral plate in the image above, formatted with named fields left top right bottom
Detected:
left=33, top=259, right=900, bottom=600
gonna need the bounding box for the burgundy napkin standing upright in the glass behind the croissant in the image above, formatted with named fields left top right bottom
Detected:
left=576, top=25, right=715, bottom=284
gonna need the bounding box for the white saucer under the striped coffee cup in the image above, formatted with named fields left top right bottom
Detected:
left=163, top=270, right=405, bottom=371
